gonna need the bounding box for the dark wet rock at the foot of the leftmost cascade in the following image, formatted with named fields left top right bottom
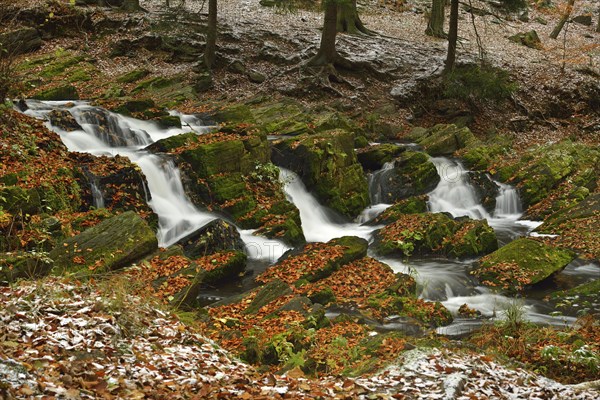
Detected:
left=176, top=219, right=245, bottom=258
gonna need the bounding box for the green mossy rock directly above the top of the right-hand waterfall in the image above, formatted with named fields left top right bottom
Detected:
left=407, top=124, right=478, bottom=157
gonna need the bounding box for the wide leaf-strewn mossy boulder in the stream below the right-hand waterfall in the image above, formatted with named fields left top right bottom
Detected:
left=375, top=213, right=498, bottom=258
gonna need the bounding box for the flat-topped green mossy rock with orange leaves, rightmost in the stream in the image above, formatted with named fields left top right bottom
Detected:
left=471, top=238, right=575, bottom=291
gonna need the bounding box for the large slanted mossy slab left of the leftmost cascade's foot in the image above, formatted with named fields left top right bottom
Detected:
left=50, top=211, right=158, bottom=275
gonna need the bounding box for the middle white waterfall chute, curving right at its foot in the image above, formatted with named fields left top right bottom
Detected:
left=279, top=168, right=377, bottom=242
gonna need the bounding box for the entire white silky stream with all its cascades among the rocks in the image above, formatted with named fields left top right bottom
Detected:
left=25, top=100, right=597, bottom=335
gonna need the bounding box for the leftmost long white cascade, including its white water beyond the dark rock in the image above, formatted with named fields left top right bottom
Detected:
left=21, top=101, right=289, bottom=261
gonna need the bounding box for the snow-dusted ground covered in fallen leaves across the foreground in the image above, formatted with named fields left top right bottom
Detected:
left=0, top=278, right=600, bottom=399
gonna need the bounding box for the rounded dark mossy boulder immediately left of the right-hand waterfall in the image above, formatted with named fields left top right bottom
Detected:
left=371, top=151, right=440, bottom=204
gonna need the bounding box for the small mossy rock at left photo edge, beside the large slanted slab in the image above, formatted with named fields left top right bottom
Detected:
left=0, top=252, right=53, bottom=283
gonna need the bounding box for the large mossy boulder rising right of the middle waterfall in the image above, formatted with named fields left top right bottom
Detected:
left=272, top=130, right=369, bottom=218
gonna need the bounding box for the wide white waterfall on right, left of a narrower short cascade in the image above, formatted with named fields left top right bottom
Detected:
left=429, top=157, right=490, bottom=219
